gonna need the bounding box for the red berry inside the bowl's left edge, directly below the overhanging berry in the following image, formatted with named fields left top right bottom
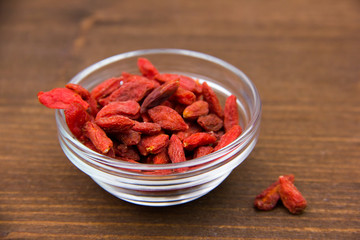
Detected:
left=64, top=102, right=91, bottom=139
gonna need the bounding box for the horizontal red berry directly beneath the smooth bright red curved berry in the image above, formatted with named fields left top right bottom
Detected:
left=95, top=115, right=135, bottom=133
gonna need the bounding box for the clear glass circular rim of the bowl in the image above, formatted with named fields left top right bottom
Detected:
left=55, top=48, right=262, bottom=172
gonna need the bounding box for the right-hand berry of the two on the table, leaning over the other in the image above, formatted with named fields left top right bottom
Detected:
left=278, top=176, right=307, bottom=214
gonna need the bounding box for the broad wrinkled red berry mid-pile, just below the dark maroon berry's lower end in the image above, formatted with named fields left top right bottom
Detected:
left=148, top=106, right=189, bottom=131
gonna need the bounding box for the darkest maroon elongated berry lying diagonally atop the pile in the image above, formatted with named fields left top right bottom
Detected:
left=141, top=80, right=179, bottom=113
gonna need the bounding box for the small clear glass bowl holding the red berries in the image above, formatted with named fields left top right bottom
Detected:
left=55, top=49, right=261, bottom=206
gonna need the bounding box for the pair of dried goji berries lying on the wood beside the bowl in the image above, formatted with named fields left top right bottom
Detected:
left=254, top=175, right=307, bottom=214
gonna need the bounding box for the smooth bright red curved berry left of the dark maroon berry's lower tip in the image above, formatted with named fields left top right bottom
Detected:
left=96, top=100, right=140, bottom=119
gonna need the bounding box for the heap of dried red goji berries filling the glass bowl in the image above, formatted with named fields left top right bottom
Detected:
left=38, top=58, right=242, bottom=174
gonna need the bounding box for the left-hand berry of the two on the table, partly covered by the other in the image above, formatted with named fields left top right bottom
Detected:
left=254, top=175, right=294, bottom=211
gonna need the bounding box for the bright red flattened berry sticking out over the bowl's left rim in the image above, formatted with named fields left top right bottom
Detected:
left=37, top=88, right=89, bottom=109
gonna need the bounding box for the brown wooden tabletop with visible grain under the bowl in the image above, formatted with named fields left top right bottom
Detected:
left=0, top=0, right=360, bottom=239
